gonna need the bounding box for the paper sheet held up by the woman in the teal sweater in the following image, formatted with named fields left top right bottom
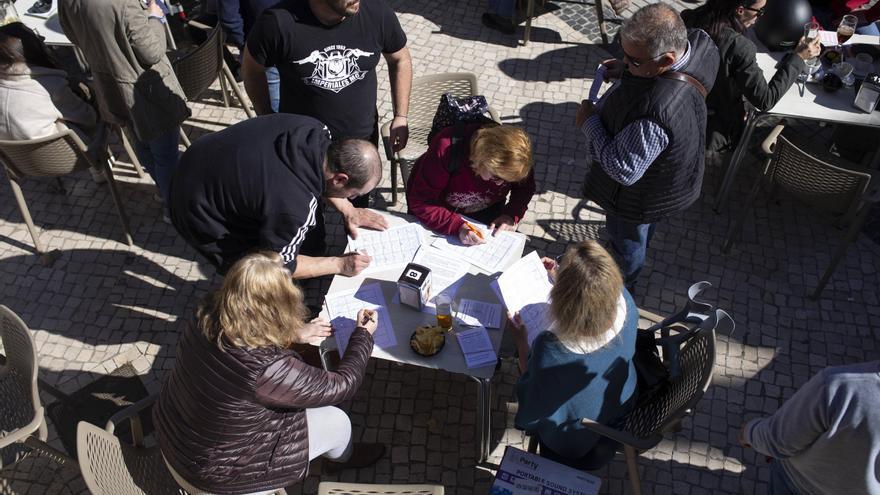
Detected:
left=496, top=251, right=553, bottom=345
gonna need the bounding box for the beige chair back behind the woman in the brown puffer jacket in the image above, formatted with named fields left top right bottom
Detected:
left=76, top=421, right=184, bottom=495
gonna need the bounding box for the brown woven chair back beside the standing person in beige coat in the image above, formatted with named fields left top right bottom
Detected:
left=171, top=23, right=223, bottom=101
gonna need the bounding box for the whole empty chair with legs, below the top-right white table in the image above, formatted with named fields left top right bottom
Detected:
left=722, top=124, right=880, bottom=300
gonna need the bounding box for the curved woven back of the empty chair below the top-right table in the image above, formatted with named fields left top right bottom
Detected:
left=767, top=132, right=871, bottom=217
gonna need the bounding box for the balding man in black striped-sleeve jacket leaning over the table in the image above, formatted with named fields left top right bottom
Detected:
left=170, top=114, right=382, bottom=278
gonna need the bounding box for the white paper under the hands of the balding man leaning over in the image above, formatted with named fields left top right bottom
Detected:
left=348, top=223, right=425, bottom=272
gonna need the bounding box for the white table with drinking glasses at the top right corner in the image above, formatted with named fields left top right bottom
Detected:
left=715, top=30, right=880, bottom=212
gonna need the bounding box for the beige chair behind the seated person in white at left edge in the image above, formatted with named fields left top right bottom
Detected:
left=0, top=129, right=134, bottom=254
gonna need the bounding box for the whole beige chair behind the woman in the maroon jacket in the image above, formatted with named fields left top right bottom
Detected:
left=380, top=72, right=500, bottom=205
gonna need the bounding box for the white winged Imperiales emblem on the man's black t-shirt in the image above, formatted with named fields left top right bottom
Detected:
left=293, top=45, right=373, bottom=93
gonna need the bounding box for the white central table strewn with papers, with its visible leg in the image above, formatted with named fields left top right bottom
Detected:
left=320, top=212, right=526, bottom=462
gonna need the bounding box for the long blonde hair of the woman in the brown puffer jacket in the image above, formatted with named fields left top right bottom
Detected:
left=196, top=251, right=308, bottom=350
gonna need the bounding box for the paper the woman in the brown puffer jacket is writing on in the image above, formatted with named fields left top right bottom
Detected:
left=325, top=284, right=397, bottom=356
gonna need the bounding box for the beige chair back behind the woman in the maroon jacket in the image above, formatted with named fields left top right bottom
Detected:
left=403, top=72, right=479, bottom=158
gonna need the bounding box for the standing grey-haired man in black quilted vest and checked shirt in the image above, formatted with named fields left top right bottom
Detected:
left=575, top=3, right=719, bottom=292
